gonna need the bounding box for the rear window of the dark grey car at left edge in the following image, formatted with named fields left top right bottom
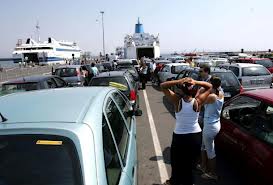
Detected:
left=2, top=82, right=38, bottom=93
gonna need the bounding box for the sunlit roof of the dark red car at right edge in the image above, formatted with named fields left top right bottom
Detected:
left=243, top=89, right=273, bottom=104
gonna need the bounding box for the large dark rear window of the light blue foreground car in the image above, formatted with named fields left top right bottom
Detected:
left=0, top=135, right=83, bottom=185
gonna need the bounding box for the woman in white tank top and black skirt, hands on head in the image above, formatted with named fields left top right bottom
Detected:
left=161, top=78, right=212, bottom=185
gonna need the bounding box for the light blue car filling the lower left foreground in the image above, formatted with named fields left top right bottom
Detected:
left=0, top=87, right=137, bottom=185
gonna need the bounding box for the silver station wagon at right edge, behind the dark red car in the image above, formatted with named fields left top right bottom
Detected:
left=219, top=63, right=272, bottom=90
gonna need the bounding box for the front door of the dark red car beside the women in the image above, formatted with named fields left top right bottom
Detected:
left=219, top=95, right=261, bottom=159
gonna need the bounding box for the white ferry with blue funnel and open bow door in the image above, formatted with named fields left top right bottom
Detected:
left=124, top=19, right=160, bottom=59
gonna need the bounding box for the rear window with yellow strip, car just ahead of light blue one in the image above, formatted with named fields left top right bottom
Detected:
left=90, top=76, right=129, bottom=91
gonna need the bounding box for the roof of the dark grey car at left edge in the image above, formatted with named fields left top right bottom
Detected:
left=2, top=75, right=56, bottom=85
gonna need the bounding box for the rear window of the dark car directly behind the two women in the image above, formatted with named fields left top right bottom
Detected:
left=212, top=72, right=240, bottom=87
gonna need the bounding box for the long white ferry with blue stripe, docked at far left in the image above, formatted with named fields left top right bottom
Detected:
left=12, top=37, right=81, bottom=65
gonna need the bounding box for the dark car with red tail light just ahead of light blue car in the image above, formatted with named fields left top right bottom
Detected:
left=89, top=71, right=139, bottom=110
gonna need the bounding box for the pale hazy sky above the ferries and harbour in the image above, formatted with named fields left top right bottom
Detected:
left=0, top=0, right=273, bottom=57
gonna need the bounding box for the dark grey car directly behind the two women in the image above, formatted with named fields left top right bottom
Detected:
left=173, top=67, right=241, bottom=101
